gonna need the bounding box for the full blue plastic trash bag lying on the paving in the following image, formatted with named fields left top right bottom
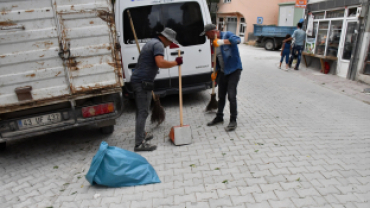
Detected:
left=85, top=141, right=161, bottom=187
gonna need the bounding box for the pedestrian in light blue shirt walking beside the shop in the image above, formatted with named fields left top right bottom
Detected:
left=283, top=23, right=306, bottom=70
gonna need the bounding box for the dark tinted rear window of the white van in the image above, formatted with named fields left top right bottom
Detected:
left=123, top=2, right=206, bottom=46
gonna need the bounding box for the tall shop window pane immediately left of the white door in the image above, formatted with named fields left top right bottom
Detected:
left=326, top=20, right=343, bottom=57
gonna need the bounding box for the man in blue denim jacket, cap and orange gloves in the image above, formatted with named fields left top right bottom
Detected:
left=200, top=24, right=242, bottom=131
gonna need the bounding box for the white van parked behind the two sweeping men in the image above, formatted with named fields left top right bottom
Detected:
left=115, top=0, right=212, bottom=97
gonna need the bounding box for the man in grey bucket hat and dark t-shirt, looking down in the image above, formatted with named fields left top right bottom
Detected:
left=131, top=28, right=183, bottom=151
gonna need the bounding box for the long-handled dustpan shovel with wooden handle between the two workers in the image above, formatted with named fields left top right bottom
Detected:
left=170, top=50, right=192, bottom=145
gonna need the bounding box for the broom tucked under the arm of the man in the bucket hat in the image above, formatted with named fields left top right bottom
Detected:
left=127, top=10, right=166, bottom=126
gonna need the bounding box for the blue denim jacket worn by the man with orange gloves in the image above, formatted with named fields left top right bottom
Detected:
left=214, top=31, right=243, bottom=75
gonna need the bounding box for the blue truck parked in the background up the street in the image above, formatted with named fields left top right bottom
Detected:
left=253, top=24, right=297, bottom=51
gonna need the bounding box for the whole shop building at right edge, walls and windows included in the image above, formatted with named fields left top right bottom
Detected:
left=305, top=0, right=370, bottom=83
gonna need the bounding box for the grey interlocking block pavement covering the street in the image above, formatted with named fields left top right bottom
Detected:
left=0, top=45, right=370, bottom=208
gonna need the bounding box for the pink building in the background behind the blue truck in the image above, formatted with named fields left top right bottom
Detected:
left=216, top=0, right=294, bottom=42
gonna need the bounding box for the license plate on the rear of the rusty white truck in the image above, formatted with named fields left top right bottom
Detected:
left=18, top=113, right=62, bottom=129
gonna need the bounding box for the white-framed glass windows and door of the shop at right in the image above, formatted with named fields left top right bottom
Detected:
left=305, top=5, right=361, bottom=78
